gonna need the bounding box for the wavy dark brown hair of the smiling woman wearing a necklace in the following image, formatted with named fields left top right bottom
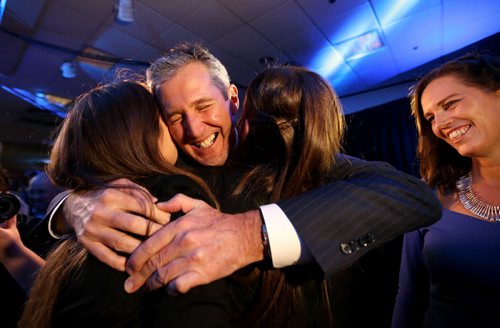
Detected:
left=410, top=53, right=500, bottom=192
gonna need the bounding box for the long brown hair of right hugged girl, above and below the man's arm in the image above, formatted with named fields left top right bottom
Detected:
left=233, top=66, right=345, bottom=327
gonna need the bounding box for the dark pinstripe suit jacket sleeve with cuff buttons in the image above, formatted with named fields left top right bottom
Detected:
left=278, top=155, right=441, bottom=276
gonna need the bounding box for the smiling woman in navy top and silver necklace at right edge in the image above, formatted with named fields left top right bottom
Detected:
left=393, top=55, right=500, bottom=327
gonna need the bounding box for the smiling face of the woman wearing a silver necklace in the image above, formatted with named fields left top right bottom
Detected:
left=421, top=75, right=500, bottom=157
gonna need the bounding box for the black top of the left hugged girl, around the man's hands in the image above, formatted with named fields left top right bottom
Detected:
left=52, top=175, right=229, bottom=327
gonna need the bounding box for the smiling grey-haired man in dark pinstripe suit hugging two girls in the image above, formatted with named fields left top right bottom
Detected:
left=45, top=43, right=441, bottom=293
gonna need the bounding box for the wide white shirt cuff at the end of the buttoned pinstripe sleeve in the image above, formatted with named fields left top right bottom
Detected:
left=260, top=204, right=311, bottom=268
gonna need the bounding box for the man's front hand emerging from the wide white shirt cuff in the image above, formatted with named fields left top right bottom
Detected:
left=125, top=194, right=263, bottom=294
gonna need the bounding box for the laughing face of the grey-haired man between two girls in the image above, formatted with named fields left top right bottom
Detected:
left=158, top=62, right=239, bottom=166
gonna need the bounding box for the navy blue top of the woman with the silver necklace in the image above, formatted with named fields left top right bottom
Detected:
left=392, top=209, right=500, bottom=328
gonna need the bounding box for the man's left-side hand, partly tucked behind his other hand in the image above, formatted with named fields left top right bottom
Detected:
left=64, top=179, right=170, bottom=271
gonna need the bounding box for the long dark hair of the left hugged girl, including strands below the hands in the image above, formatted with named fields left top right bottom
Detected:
left=19, top=82, right=213, bottom=327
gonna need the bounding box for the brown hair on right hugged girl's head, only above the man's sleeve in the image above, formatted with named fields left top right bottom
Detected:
left=236, top=66, right=345, bottom=201
